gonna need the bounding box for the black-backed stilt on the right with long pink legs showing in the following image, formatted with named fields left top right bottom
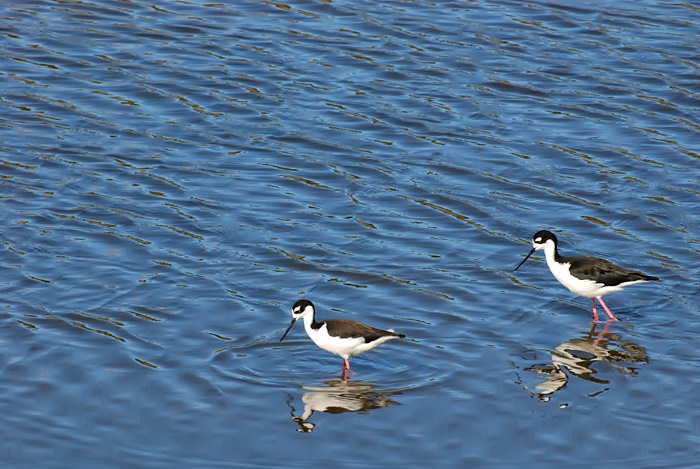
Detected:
left=515, top=230, right=661, bottom=322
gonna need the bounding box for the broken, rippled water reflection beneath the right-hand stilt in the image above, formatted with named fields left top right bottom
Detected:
left=525, top=321, right=649, bottom=402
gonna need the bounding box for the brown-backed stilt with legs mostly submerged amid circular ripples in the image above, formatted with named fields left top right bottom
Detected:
left=280, top=300, right=405, bottom=374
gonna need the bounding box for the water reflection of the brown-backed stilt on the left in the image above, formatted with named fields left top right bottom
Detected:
left=287, top=379, right=401, bottom=433
